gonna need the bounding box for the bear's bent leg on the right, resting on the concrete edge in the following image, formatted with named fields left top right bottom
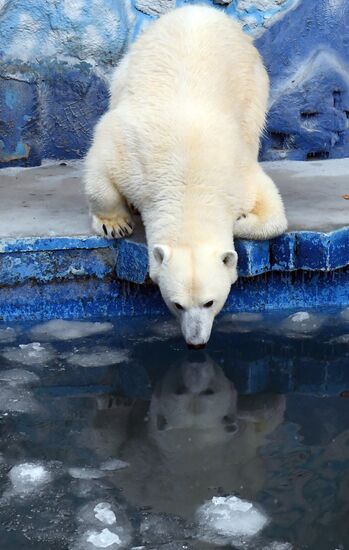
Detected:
left=234, top=164, right=287, bottom=240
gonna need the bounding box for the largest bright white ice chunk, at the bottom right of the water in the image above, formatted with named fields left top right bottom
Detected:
left=196, top=496, right=268, bottom=545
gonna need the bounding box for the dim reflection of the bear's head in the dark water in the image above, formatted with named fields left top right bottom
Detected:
left=149, top=352, right=238, bottom=444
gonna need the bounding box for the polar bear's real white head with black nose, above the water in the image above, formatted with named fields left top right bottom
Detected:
left=150, top=244, right=238, bottom=349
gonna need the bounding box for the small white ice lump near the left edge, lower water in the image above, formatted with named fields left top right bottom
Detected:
left=8, top=462, right=52, bottom=493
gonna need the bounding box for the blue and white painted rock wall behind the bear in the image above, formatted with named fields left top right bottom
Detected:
left=0, top=0, right=349, bottom=166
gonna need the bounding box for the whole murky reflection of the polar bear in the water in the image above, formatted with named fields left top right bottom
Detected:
left=86, top=356, right=285, bottom=518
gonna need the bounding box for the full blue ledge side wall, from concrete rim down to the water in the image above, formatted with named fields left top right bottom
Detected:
left=0, top=227, right=349, bottom=321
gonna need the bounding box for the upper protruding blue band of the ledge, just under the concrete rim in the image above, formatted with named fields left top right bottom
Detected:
left=0, top=227, right=349, bottom=285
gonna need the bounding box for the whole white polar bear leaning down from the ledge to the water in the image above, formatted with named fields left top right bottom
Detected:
left=85, top=6, right=287, bottom=348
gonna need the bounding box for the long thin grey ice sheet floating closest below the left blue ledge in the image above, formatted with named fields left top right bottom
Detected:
left=31, top=319, right=113, bottom=340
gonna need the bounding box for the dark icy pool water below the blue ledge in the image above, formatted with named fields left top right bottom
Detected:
left=0, top=310, right=349, bottom=550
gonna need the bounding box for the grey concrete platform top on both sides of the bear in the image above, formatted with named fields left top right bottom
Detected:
left=0, top=159, right=349, bottom=240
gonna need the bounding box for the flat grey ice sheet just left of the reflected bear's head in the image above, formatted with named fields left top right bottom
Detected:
left=65, top=346, right=129, bottom=367
